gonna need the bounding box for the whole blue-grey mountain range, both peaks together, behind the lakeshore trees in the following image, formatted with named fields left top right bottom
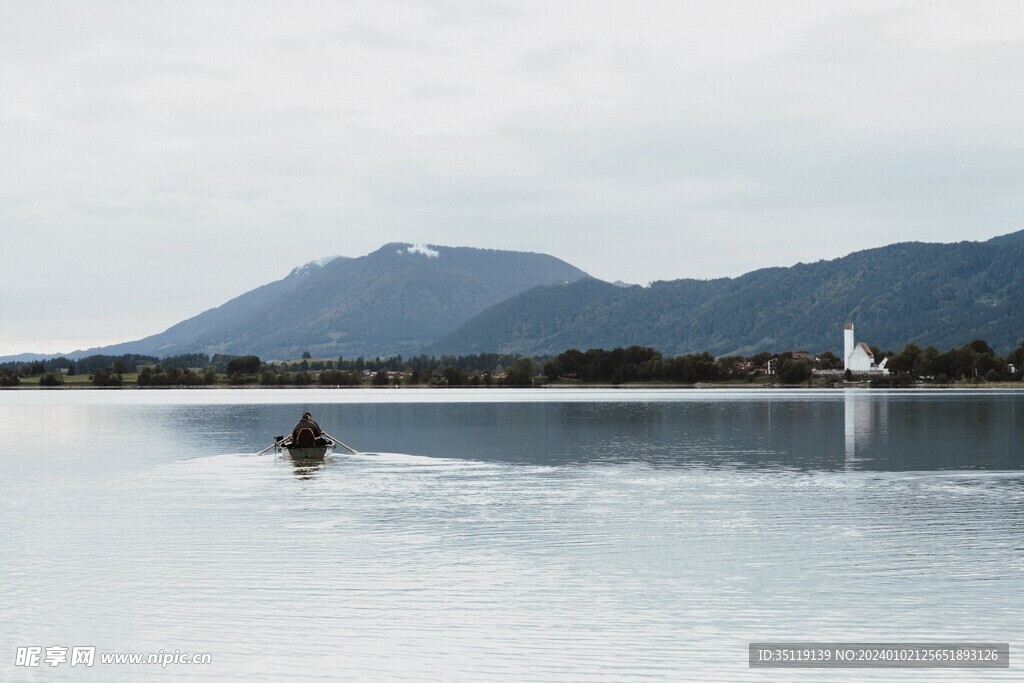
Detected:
left=8, top=230, right=1024, bottom=361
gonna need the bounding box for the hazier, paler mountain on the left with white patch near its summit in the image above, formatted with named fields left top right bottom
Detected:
left=78, top=243, right=587, bottom=358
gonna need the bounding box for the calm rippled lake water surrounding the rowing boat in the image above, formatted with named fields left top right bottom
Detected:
left=0, top=389, right=1024, bottom=681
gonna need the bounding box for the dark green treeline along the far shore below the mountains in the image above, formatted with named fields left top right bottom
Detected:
left=0, top=339, right=1024, bottom=388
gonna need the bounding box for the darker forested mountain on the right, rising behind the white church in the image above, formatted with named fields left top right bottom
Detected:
left=430, top=230, right=1024, bottom=355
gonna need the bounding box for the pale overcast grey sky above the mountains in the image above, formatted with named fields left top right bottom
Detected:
left=0, top=0, right=1024, bottom=355
